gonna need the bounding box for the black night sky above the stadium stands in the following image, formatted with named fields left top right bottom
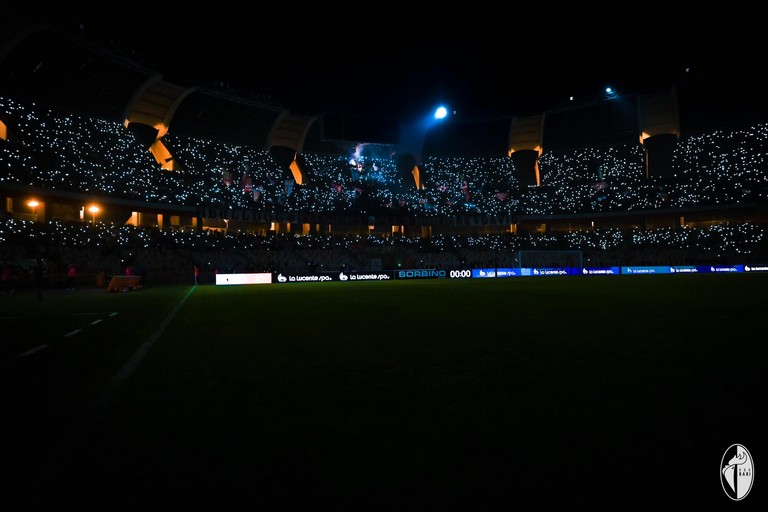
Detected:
left=6, top=8, right=768, bottom=130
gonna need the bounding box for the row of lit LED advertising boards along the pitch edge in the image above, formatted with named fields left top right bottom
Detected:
left=216, top=264, right=768, bottom=285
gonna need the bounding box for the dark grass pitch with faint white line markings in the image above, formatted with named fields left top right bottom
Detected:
left=0, top=274, right=768, bottom=510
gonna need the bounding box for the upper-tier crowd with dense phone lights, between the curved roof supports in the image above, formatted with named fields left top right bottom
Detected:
left=0, top=97, right=768, bottom=215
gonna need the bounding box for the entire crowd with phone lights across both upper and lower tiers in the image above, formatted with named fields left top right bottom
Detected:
left=0, top=97, right=768, bottom=288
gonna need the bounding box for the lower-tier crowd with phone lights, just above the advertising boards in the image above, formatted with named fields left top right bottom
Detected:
left=0, top=219, right=768, bottom=284
